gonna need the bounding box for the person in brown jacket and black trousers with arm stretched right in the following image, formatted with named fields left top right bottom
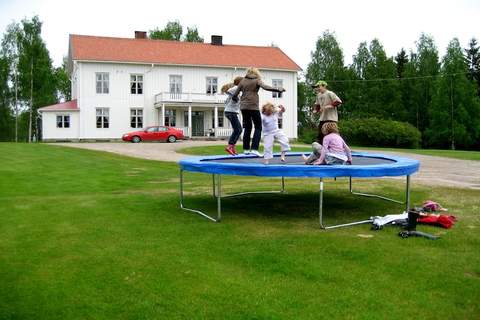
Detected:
left=232, top=68, right=285, bottom=157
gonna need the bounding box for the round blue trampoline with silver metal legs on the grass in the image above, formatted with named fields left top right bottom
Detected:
left=179, top=152, right=420, bottom=229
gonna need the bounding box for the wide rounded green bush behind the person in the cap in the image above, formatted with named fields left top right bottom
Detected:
left=299, top=118, right=421, bottom=148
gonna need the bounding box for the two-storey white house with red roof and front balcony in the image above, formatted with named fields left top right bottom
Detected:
left=39, top=31, right=301, bottom=141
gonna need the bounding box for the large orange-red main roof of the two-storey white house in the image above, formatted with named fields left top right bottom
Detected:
left=70, top=34, right=301, bottom=71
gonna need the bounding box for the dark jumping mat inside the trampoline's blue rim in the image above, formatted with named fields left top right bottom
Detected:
left=201, top=155, right=396, bottom=166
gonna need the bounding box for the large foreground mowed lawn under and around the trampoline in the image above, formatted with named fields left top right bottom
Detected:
left=0, top=144, right=480, bottom=319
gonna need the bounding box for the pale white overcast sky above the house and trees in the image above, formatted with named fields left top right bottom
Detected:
left=0, top=0, right=480, bottom=70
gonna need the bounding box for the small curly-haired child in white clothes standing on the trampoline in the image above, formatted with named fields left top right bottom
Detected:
left=262, top=102, right=290, bottom=164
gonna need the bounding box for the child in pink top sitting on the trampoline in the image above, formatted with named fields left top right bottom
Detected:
left=302, top=122, right=352, bottom=165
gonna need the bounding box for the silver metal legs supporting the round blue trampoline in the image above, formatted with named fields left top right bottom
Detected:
left=179, top=153, right=410, bottom=230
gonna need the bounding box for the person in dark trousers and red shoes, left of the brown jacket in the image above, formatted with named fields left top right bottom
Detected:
left=222, top=77, right=243, bottom=156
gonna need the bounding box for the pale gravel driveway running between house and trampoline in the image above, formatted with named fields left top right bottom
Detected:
left=54, top=140, right=480, bottom=190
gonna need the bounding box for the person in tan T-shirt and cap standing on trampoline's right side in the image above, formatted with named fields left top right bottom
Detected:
left=312, top=80, right=342, bottom=144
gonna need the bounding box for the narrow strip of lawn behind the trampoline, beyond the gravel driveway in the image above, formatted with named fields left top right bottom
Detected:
left=178, top=144, right=480, bottom=161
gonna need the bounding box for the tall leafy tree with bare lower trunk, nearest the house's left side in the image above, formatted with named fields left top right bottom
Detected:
left=18, top=16, right=57, bottom=142
